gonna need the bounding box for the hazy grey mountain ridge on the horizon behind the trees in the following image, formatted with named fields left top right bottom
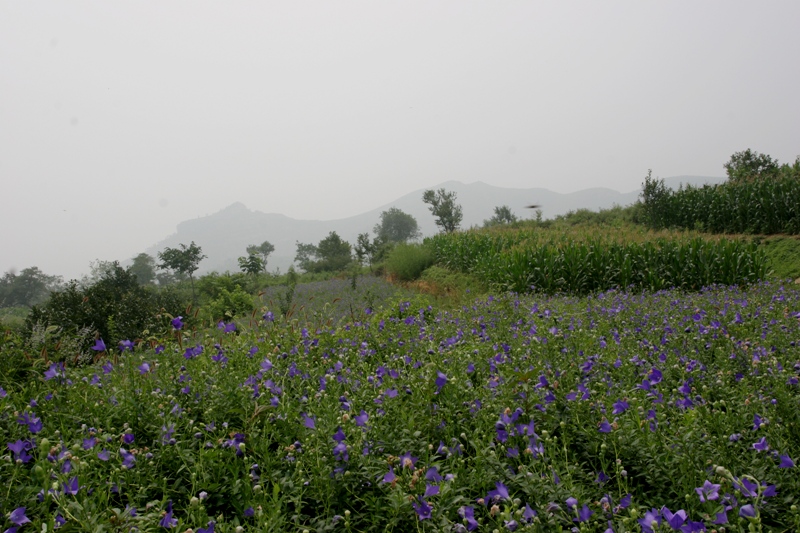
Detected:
left=147, top=180, right=724, bottom=273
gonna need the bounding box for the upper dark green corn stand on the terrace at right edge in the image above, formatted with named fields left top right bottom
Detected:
left=642, top=177, right=800, bottom=235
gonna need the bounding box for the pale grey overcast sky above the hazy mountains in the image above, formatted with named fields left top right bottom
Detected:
left=0, top=0, right=800, bottom=278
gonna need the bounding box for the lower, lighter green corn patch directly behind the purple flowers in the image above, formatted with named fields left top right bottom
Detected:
left=427, top=230, right=768, bottom=294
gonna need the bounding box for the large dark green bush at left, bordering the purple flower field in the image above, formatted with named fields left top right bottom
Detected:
left=25, top=263, right=184, bottom=351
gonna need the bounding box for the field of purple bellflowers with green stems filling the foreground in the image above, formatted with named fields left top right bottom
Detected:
left=0, top=283, right=800, bottom=533
